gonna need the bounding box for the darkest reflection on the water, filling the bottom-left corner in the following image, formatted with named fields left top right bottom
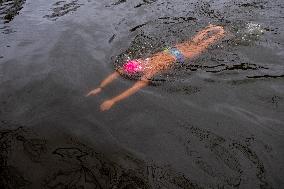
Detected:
left=0, top=122, right=203, bottom=189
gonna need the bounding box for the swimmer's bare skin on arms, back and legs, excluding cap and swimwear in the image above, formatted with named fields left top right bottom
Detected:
left=86, top=25, right=225, bottom=111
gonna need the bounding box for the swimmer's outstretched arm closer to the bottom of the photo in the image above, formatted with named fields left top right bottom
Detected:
left=100, top=71, right=157, bottom=111
